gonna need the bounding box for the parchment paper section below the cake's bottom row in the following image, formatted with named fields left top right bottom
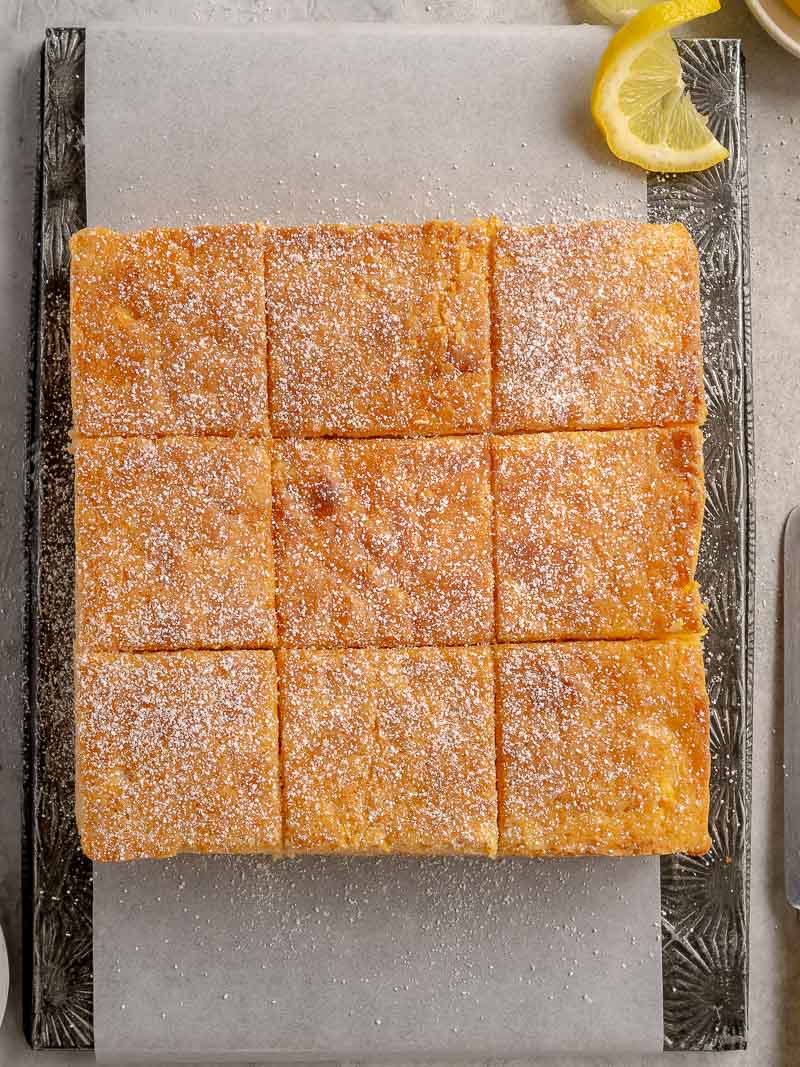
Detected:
left=94, top=857, right=662, bottom=1063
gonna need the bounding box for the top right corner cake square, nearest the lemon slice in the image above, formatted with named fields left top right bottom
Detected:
left=493, top=222, right=705, bottom=432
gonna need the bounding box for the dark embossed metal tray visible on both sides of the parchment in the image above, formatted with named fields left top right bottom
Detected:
left=23, top=29, right=755, bottom=1050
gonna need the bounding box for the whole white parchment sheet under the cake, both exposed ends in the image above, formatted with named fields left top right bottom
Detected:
left=86, top=26, right=662, bottom=1063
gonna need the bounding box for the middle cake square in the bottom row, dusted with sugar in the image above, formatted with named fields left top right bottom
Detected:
left=278, top=648, right=497, bottom=856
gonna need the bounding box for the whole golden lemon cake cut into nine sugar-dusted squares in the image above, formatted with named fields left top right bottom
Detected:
left=70, top=220, right=709, bottom=861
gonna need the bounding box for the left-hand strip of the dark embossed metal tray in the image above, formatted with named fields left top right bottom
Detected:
left=22, top=29, right=94, bottom=1049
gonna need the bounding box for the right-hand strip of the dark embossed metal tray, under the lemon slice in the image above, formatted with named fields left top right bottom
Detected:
left=647, top=41, right=755, bottom=1051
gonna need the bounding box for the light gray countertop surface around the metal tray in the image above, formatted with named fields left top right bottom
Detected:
left=0, top=0, right=800, bottom=1067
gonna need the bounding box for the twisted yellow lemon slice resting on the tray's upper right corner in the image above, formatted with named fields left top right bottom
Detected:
left=592, top=0, right=729, bottom=171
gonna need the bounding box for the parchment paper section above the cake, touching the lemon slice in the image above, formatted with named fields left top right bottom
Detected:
left=86, top=25, right=645, bottom=229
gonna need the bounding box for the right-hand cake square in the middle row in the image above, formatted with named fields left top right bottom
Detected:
left=493, top=429, right=704, bottom=641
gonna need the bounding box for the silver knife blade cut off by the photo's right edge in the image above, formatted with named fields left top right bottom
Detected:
left=783, top=507, right=800, bottom=909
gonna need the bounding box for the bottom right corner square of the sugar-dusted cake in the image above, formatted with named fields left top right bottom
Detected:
left=497, top=636, right=710, bottom=856
